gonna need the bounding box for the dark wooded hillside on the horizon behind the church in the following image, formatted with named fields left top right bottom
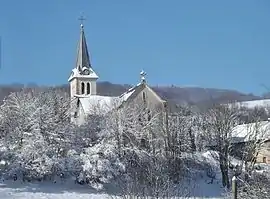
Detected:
left=0, top=82, right=267, bottom=106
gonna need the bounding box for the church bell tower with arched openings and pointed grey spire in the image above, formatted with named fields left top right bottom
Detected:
left=68, top=17, right=98, bottom=100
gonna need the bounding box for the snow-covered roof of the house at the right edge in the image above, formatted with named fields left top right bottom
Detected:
left=232, top=121, right=270, bottom=143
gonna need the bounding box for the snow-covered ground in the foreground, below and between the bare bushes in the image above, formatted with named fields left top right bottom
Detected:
left=0, top=151, right=230, bottom=199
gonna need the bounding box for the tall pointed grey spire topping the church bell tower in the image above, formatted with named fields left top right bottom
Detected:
left=76, top=17, right=91, bottom=72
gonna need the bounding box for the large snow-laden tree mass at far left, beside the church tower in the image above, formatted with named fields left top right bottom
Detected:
left=0, top=89, right=75, bottom=179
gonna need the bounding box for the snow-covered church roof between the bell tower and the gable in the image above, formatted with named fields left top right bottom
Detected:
left=76, top=84, right=140, bottom=115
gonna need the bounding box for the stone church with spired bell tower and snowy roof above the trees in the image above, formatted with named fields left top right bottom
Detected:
left=68, top=21, right=167, bottom=125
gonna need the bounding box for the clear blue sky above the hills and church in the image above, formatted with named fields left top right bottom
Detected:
left=0, top=0, right=270, bottom=94
